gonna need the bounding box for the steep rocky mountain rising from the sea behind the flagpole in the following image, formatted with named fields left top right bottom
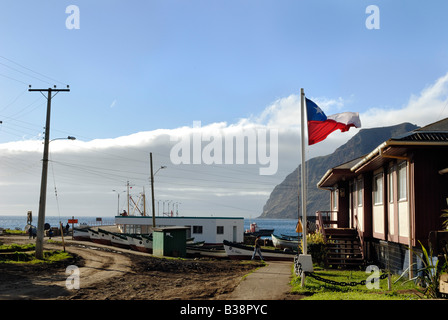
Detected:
left=259, top=123, right=418, bottom=219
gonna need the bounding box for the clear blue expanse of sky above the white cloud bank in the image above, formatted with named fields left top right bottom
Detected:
left=0, top=0, right=448, bottom=142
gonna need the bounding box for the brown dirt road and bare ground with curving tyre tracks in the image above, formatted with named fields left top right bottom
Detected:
left=0, top=236, right=272, bottom=300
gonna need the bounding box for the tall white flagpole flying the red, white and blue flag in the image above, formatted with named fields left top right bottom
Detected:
left=300, top=88, right=307, bottom=287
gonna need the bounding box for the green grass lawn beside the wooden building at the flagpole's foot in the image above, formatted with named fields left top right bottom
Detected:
left=291, top=267, right=419, bottom=300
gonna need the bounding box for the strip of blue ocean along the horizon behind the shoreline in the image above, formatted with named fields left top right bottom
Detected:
left=0, top=215, right=297, bottom=235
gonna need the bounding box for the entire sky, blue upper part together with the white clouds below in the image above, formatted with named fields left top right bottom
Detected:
left=0, top=0, right=448, bottom=217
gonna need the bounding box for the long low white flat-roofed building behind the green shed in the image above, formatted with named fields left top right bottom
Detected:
left=115, top=216, right=244, bottom=245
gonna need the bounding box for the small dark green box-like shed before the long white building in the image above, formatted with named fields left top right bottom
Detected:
left=152, top=226, right=190, bottom=257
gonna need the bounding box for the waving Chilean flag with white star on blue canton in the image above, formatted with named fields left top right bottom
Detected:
left=305, top=98, right=361, bottom=145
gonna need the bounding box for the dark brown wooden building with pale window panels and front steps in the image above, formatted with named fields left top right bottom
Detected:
left=318, top=118, right=448, bottom=272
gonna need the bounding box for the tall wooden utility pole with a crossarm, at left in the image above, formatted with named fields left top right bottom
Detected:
left=28, top=86, right=70, bottom=260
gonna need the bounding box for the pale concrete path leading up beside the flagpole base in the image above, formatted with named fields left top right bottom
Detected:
left=220, top=261, right=293, bottom=300
